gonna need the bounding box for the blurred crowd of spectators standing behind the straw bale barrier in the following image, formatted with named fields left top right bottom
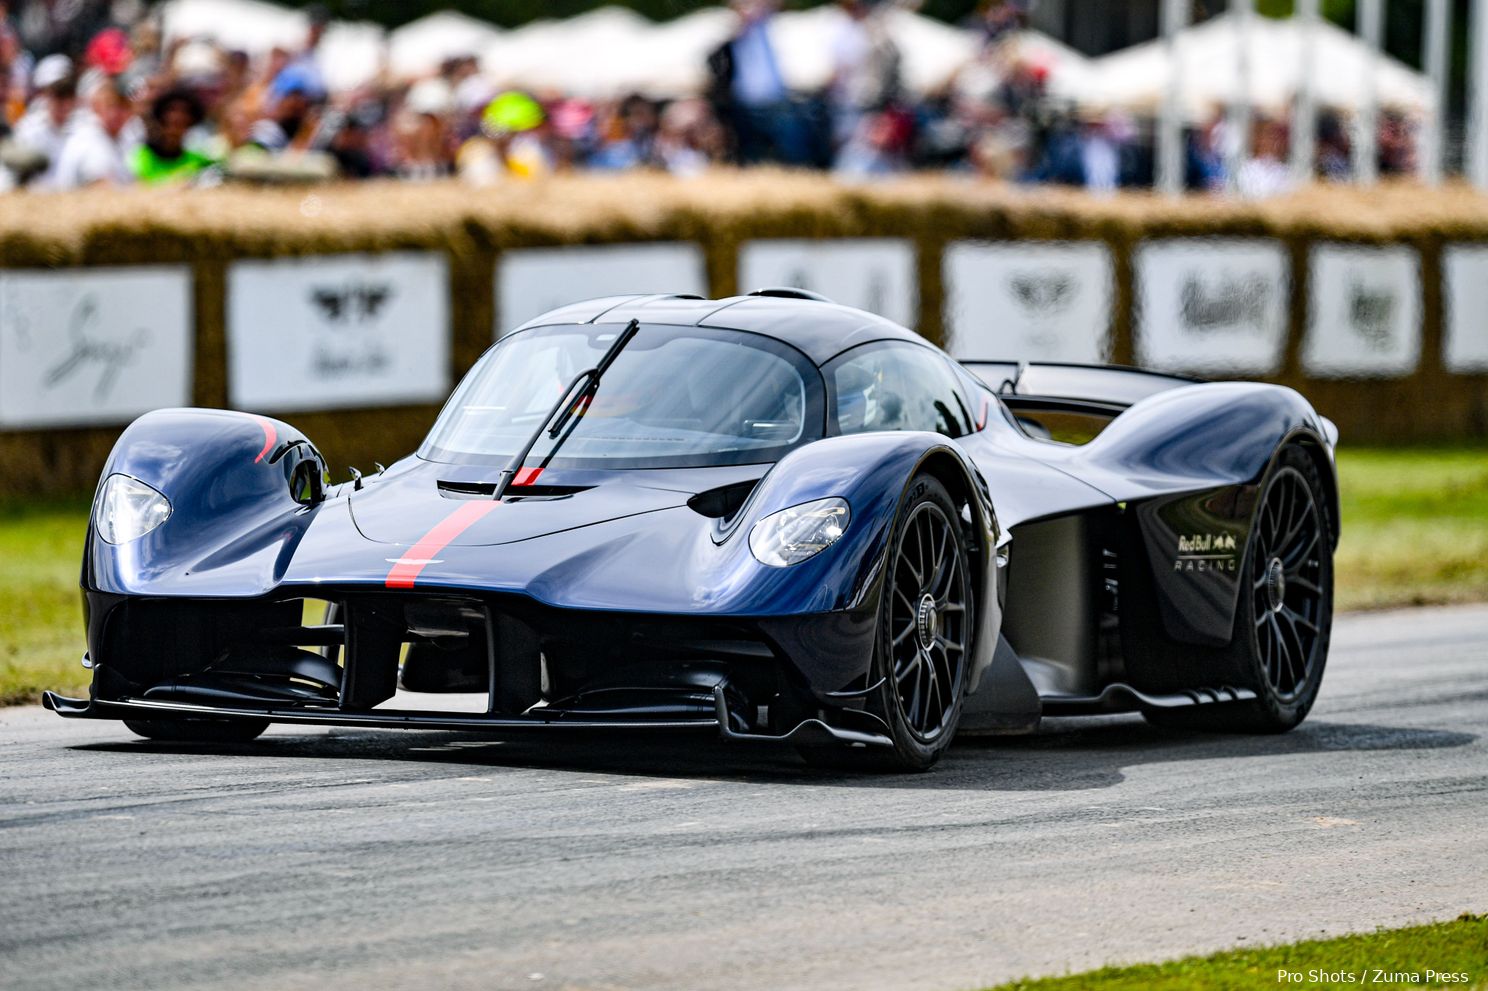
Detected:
left=0, top=0, right=1414, bottom=196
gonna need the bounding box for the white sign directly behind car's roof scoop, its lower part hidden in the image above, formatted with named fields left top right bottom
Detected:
left=740, top=238, right=920, bottom=327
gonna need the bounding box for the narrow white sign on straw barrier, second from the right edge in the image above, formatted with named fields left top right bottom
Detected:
left=1302, top=244, right=1421, bottom=378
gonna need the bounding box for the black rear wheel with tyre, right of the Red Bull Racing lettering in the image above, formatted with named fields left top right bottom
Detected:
left=1144, top=446, right=1333, bottom=734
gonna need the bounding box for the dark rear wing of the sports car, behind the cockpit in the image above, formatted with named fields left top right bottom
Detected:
left=961, top=360, right=1204, bottom=415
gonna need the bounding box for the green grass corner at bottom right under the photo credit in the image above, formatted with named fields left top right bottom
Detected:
left=991, top=915, right=1488, bottom=991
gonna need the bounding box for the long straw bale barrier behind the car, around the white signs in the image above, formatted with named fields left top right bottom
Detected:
left=0, top=171, right=1488, bottom=497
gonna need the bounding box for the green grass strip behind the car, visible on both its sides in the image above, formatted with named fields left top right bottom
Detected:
left=0, top=446, right=1488, bottom=704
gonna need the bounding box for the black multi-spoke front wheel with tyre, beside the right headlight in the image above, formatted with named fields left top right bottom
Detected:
left=801, top=475, right=976, bottom=771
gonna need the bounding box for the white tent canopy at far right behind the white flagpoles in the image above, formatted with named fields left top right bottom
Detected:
left=1085, top=15, right=1433, bottom=121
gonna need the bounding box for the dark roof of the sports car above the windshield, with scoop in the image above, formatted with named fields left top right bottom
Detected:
left=516, top=295, right=934, bottom=365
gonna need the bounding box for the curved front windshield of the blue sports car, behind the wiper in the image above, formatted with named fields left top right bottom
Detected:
left=420, top=324, right=826, bottom=467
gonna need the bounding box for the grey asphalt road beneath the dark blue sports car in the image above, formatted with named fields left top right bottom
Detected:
left=0, top=607, right=1488, bottom=991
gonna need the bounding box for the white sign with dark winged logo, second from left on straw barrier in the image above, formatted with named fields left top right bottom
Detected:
left=228, top=253, right=449, bottom=411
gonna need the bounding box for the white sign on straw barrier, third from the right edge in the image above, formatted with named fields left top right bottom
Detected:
left=1134, top=238, right=1290, bottom=375
